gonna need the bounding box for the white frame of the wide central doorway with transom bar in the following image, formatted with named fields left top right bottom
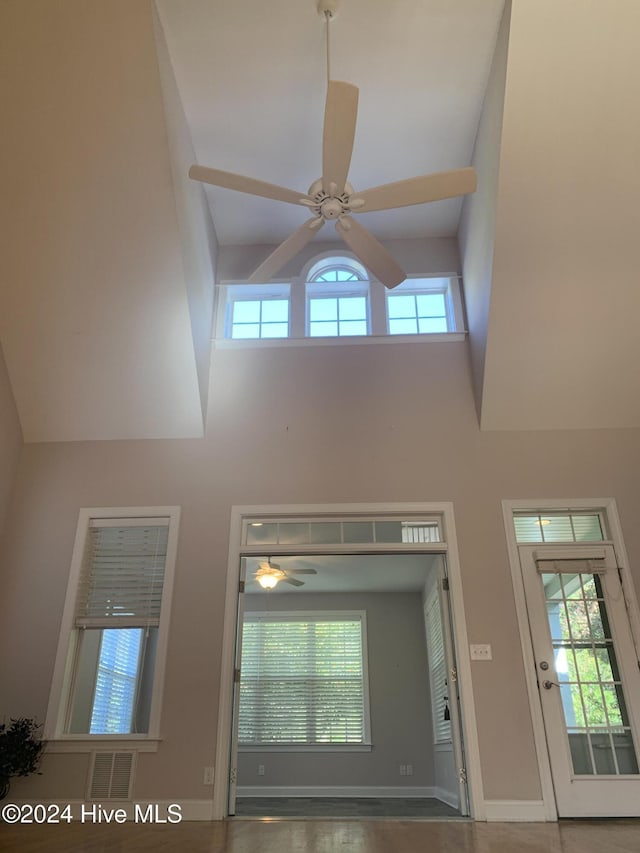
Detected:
left=213, top=502, right=486, bottom=820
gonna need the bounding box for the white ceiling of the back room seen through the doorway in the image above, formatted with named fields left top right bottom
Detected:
left=245, top=554, right=440, bottom=596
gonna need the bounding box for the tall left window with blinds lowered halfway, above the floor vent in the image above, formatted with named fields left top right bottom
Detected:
left=48, top=508, right=178, bottom=737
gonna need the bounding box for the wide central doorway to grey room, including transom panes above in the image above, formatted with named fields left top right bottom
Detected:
left=212, top=505, right=479, bottom=819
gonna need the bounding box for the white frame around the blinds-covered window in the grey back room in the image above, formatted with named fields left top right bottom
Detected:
left=238, top=610, right=372, bottom=752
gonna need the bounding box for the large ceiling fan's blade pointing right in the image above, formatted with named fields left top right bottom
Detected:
left=356, top=167, right=477, bottom=213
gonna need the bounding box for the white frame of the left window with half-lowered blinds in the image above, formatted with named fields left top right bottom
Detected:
left=44, top=506, right=180, bottom=752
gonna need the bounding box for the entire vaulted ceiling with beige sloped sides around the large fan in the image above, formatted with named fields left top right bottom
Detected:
left=0, top=0, right=640, bottom=441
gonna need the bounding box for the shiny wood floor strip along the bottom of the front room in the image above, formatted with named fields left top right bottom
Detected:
left=0, top=820, right=640, bottom=853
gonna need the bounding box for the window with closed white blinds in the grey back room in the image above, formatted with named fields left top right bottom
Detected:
left=238, top=612, right=370, bottom=746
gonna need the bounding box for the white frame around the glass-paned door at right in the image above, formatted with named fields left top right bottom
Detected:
left=502, top=498, right=640, bottom=821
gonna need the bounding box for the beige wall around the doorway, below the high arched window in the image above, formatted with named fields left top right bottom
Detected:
left=0, top=342, right=640, bottom=800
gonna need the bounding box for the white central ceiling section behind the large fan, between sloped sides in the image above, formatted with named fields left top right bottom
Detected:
left=157, top=0, right=504, bottom=245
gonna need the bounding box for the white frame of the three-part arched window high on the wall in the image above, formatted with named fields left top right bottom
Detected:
left=214, top=252, right=466, bottom=349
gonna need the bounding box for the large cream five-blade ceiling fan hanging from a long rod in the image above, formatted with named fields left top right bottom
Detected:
left=189, top=0, right=476, bottom=288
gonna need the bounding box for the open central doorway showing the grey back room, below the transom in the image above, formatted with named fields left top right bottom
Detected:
left=229, top=554, right=467, bottom=818
